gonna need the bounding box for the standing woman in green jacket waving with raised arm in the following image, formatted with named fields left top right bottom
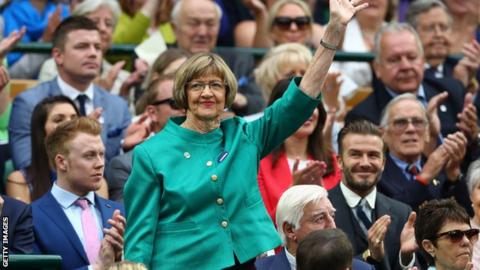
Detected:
left=124, top=0, right=368, bottom=269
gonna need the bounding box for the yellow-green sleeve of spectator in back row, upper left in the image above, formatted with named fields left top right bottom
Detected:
left=113, top=12, right=150, bottom=44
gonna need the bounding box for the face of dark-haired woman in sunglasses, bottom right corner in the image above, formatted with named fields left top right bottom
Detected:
left=424, top=221, right=478, bottom=270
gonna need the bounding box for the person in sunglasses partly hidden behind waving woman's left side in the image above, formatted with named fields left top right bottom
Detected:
left=105, top=75, right=184, bottom=202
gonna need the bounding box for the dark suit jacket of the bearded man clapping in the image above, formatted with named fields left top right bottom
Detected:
left=328, top=185, right=412, bottom=270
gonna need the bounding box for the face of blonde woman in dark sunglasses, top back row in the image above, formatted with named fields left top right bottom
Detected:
left=271, top=4, right=312, bottom=45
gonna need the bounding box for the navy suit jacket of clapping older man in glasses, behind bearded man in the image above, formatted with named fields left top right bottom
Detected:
left=377, top=154, right=472, bottom=213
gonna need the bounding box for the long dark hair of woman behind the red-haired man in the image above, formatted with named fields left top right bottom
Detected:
left=27, top=96, right=80, bottom=201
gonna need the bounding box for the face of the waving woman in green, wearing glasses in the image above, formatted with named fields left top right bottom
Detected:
left=186, top=75, right=227, bottom=121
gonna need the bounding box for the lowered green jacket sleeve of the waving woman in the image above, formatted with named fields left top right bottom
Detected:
left=124, top=145, right=162, bottom=267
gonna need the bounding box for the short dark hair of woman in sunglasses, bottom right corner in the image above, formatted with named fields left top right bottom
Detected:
left=415, top=198, right=470, bottom=265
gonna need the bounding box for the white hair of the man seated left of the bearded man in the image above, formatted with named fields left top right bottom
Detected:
left=275, top=185, right=328, bottom=244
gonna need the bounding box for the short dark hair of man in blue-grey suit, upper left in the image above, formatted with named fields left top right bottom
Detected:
left=52, top=16, right=99, bottom=49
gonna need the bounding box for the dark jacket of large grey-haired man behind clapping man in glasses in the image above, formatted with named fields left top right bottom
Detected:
left=345, top=77, right=465, bottom=136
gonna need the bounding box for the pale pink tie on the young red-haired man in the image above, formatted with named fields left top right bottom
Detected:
left=75, top=198, right=100, bottom=264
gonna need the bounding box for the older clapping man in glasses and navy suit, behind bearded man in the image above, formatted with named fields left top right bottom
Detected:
left=377, top=93, right=472, bottom=212
